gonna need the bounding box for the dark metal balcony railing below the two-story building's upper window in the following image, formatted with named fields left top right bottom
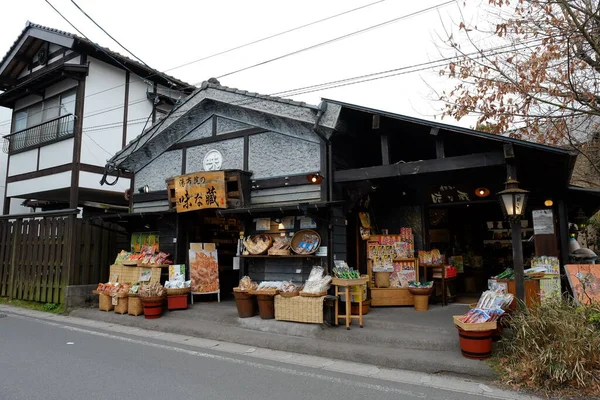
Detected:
left=2, top=114, right=75, bottom=154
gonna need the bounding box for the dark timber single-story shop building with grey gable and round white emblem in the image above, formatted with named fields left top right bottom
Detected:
left=102, top=80, right=599, bottom=305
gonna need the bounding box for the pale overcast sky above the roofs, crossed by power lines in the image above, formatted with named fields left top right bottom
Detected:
left=0, top=0, right=482, bottom=134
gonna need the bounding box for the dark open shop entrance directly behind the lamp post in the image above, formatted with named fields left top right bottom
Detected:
left=426, top=200, right=534, bottom=303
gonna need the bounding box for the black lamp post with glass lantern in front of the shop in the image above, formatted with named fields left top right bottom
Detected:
left=498, top=178, right=529, bottom=302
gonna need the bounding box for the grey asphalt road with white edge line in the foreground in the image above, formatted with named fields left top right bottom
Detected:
left=0, top=313, right=536, bottom=400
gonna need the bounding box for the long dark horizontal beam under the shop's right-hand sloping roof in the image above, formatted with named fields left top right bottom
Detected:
left=334, top=152, right=506, bottom=183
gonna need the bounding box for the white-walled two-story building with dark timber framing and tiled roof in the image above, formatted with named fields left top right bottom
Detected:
left=0, top=22, right=194, bottom=214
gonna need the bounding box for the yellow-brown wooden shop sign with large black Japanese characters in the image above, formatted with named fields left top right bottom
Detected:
left=175, top=171, right=227, bottom=212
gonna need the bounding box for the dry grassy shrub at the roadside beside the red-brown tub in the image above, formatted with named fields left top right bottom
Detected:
left=500, top=299, right=600, bottom=393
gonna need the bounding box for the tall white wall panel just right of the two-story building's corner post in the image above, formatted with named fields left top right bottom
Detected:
left=81, top=57, right=125, bottom=166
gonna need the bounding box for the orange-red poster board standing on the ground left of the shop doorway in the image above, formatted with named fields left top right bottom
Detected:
left=189, top=243, right=219, bottom=293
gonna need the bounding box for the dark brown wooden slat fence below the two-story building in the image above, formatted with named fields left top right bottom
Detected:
left=0, top=210, right=127, bottom=303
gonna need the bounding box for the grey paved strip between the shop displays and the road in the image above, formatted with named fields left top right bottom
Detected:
left=70, top=301, right=494, bottom=380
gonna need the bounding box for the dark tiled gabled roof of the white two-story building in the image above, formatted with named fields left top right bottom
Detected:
left=0, top=21, right=194, bottom=93
